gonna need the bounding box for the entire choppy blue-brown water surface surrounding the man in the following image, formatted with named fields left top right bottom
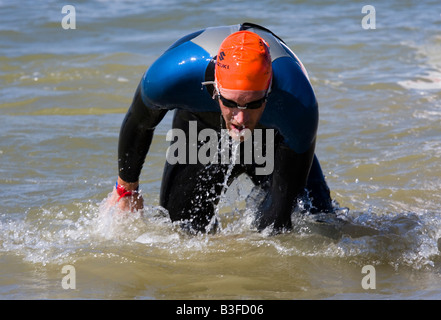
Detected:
left=0, top=0, right=441, bottom=299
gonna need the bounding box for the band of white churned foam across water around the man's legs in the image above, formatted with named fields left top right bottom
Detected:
left=0, top=186, right=441, bottom=270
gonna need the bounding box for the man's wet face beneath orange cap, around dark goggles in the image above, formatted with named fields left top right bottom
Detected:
left=219, top=89, right=266, bottom=141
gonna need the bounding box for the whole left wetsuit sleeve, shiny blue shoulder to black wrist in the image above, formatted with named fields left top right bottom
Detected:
left=118, top=32, right=217, bottom=182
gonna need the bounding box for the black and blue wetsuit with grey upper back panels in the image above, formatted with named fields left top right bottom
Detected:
left=118, top=23, right=332, bottom=231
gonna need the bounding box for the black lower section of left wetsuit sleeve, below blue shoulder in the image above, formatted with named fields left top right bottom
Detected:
left=118, top=84, right=167, bottom=182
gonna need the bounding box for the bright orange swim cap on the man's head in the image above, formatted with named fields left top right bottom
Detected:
left=215, top=31, right=272, bottom=91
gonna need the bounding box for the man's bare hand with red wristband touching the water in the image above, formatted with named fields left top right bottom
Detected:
left=108, top=177, right=144, bottom=212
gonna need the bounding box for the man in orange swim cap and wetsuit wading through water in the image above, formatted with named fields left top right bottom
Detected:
left=109, top=23, right=333, bottom=232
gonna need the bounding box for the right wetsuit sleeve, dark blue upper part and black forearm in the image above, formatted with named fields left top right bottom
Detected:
left=254, top=57, right=319, bottom=231
